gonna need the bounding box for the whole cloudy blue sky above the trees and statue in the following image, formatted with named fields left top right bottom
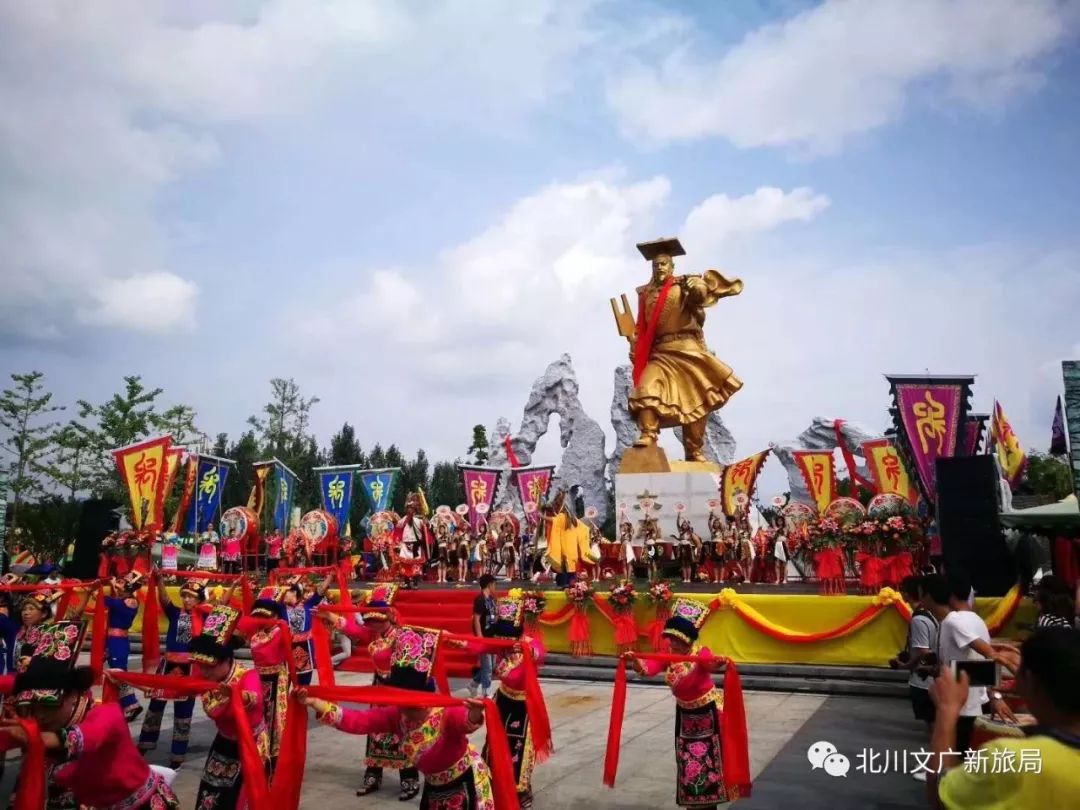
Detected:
left=0, top=0, right=1080, bottom=492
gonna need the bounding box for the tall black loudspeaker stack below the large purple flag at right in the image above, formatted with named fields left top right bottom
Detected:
left=936, top=456, right=1016, bottom=596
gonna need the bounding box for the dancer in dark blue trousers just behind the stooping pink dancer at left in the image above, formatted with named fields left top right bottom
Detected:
left=138, top=579, right=211, bottom=770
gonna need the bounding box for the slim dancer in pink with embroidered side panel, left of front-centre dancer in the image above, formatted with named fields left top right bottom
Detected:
left=238, top=586, right=293, bottom=775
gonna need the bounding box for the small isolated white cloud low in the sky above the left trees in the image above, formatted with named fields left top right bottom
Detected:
left=79, top=272, right=199, bottom=334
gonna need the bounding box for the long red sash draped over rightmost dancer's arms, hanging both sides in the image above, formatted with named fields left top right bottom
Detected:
left=604, top=652, right=751, bottom=797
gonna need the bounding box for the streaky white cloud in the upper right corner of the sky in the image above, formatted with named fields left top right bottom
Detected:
left=608, top=0, right=1072, bottom=151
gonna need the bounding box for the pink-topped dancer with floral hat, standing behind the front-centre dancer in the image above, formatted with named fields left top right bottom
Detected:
left=338, top=582, right=420, bottom=801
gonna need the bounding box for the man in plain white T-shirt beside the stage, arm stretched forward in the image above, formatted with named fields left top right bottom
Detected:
left=937, top=570, right=1013, bottom=751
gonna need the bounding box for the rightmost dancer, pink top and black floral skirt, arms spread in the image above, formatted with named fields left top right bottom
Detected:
left=625, top=598, right=739, bottom=810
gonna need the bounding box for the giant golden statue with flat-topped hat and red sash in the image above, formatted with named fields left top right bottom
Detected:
left=611, top=239, right=742, bottom=472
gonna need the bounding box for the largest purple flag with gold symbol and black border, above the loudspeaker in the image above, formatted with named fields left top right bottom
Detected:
left=886, top=376, right=975, bottom=502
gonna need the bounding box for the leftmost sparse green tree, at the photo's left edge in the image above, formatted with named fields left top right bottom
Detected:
left=0, top=372, right=64, bottom=528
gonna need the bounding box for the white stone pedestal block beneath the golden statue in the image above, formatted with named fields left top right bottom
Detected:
left=615, top=468, right=720, bottom=545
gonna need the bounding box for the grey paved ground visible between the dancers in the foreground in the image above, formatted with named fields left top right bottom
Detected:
left=0, top=673, right=924, bottom=810
